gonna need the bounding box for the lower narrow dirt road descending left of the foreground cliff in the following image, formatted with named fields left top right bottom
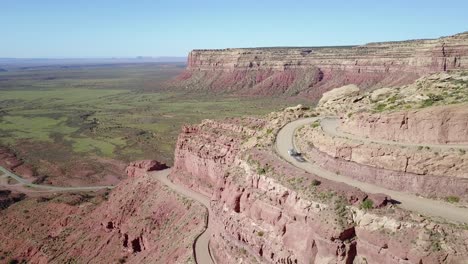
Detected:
left=150, top=169, right=214, bottom=264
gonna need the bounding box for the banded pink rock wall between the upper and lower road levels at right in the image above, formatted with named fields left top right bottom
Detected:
left=295, top=126, right=468, bottom=200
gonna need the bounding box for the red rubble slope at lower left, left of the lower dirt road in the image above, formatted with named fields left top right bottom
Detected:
left=0, top=170, right=206, bottom=264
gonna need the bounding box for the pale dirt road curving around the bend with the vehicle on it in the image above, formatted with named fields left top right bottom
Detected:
left=276, top=117, right=468, bottom=223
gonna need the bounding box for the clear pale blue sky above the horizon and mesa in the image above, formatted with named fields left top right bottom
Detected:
left=0, top=0, right=468, bottom=58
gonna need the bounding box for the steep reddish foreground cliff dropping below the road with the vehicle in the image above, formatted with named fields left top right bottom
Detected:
left=171, top=108, right=468, bottom=264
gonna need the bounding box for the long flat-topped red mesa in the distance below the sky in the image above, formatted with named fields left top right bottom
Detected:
left=176, top=33, right=468, bottom=99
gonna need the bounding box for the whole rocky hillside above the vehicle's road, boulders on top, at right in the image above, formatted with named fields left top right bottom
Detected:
left=296, top=71, right=468, bottom=202
